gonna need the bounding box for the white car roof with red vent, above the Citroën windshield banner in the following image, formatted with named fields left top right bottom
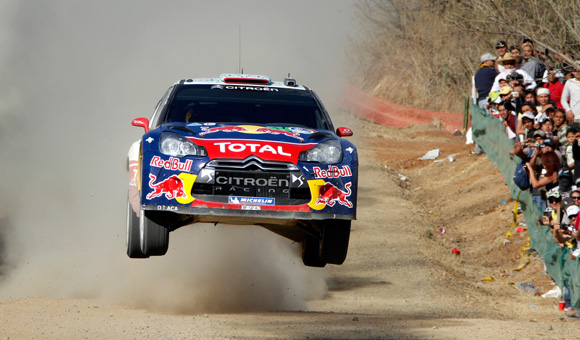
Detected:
left=174, top=73, right=307, bottom=90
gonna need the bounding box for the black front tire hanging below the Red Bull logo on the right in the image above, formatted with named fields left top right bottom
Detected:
left=320, top=220, right=351, bottom=264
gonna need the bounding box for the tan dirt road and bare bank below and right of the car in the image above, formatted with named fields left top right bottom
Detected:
left=0, top=113, right=578, bottom=340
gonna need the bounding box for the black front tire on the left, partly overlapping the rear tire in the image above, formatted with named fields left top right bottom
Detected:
left=139, top=209, right=169, bottom=256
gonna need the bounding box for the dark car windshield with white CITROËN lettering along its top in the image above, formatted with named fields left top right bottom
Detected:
left=163, top=85, right=330, bottom=130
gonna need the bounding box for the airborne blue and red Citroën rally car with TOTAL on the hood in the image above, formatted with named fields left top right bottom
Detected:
left=127, top=74, right=358, bottom=267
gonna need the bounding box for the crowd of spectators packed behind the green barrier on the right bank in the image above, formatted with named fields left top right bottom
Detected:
left=474, top=38, right=580, bottom=318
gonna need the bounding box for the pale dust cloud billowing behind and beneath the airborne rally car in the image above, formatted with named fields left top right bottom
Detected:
left=0, top=0, right=353, bottom=313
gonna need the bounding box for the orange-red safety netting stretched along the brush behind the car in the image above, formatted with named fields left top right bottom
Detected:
left=341, top=84, right=463, bottom=133
